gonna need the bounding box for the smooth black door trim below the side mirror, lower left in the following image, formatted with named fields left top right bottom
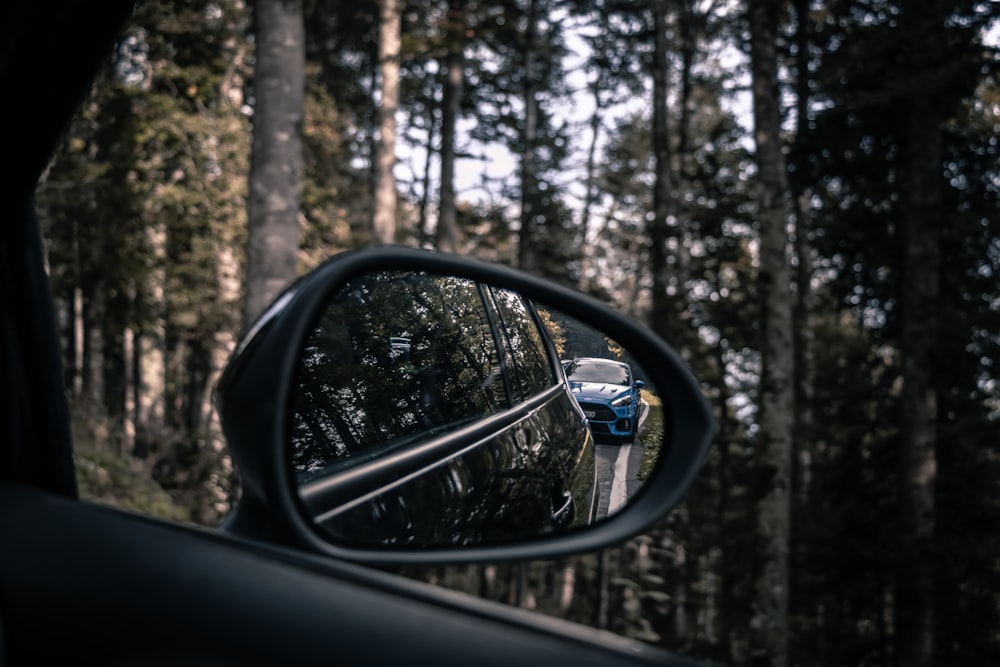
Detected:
left=0, top=484, right=696, bottom=667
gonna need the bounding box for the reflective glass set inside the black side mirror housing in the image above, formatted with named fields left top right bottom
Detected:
left=288, top=271, right=663, bottom=548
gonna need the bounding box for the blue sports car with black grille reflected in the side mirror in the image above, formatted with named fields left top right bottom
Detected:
left=563, top=357, right=646, bottom=444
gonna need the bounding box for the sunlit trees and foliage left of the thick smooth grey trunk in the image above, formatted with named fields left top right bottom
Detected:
left=38, top=2, right=250, bottom=523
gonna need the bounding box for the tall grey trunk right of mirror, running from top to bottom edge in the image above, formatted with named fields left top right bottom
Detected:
left=749, top=0, right=795, bottom=667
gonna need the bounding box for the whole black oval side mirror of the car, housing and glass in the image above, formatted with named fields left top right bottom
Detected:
left=216, top=247, right=715, bottom=565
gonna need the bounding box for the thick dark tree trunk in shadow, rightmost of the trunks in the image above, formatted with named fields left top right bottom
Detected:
left=895, top=92, right=944, bottom=667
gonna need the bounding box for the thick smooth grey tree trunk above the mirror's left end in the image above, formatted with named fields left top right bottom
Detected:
left=244, top=0, right=305, bottom=326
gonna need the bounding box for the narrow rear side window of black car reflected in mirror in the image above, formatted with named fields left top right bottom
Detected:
left=492, top=289, right=555, bottom=401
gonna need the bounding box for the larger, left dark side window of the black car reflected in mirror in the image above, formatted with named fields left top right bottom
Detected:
left=291, top=272, right=509, bottom=481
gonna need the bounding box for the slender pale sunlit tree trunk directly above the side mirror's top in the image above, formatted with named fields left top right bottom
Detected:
left=371, top=0, right=402, bottom=244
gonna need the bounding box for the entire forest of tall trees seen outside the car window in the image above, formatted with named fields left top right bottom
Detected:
left=37, top=0, right=1000, bottom=667
